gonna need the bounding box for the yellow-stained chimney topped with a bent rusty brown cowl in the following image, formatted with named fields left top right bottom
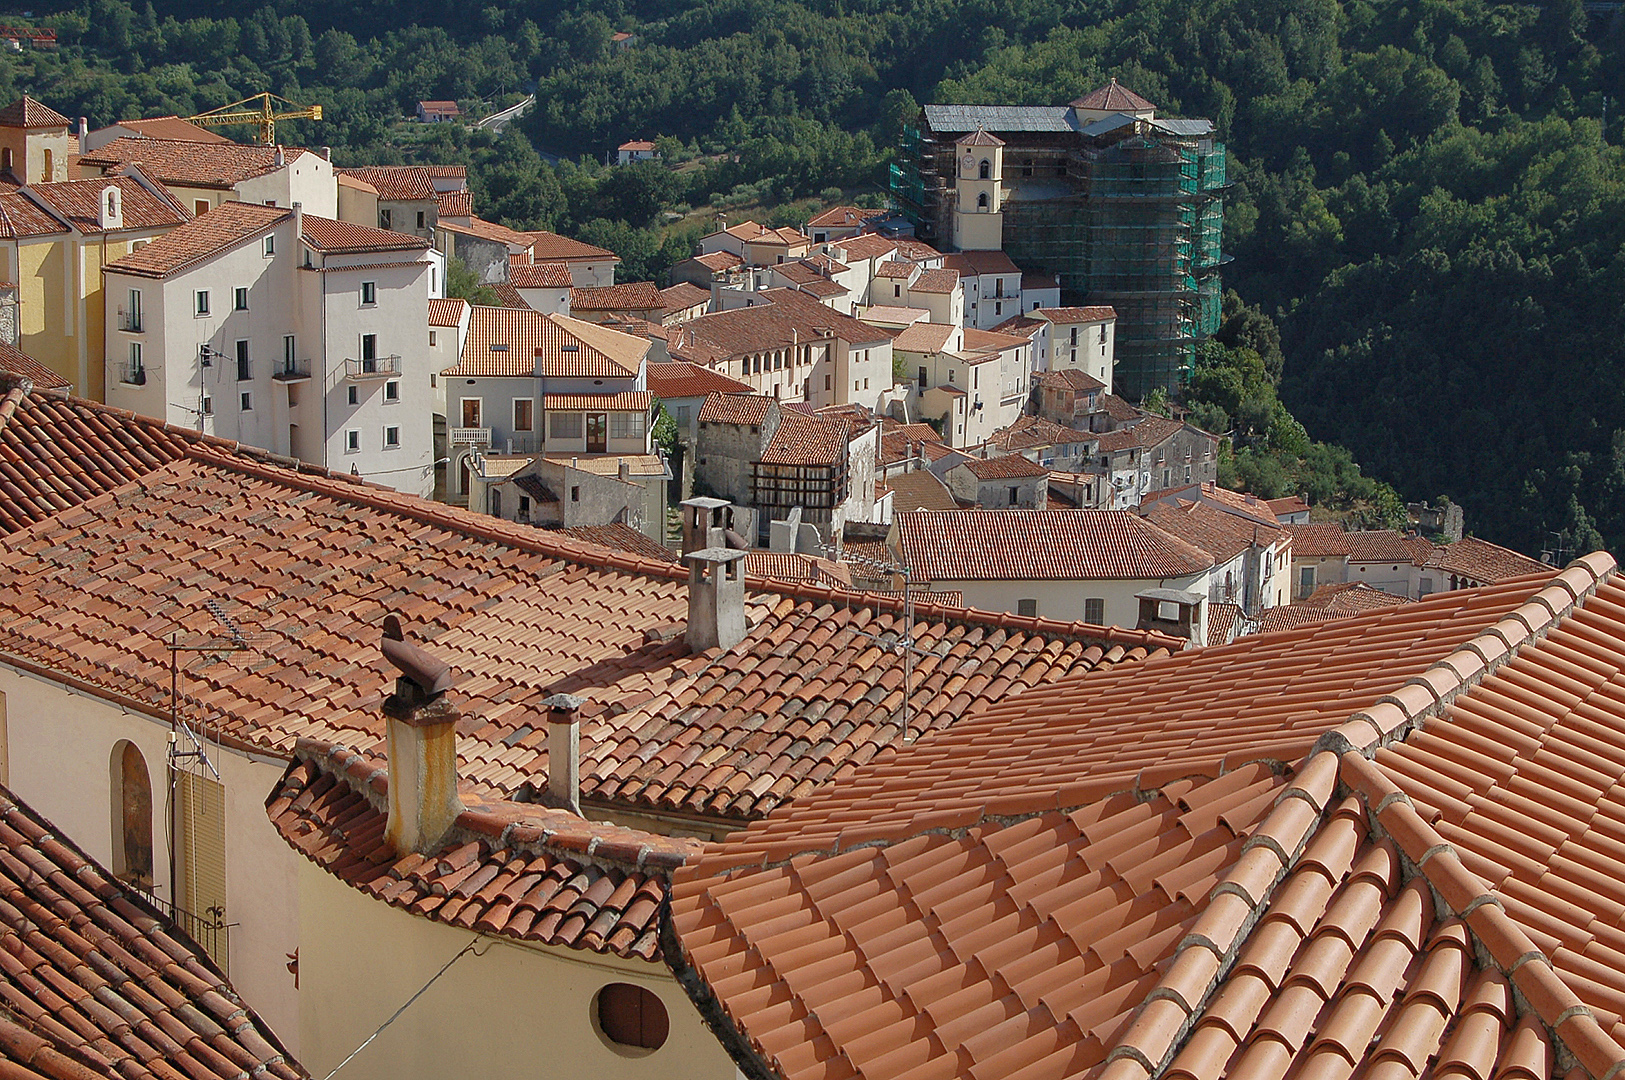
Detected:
left=382, top=616, right=463, bottom=854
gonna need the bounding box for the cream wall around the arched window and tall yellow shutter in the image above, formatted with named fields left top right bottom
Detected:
left=0, top=666, right=302, bottom=1056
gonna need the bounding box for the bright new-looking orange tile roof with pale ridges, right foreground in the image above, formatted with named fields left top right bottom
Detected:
left=670, top=555, right=1625, bottom=1080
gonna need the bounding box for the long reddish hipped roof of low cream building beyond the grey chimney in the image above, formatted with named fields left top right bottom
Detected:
left=895, top=510, right=1214, bottom=581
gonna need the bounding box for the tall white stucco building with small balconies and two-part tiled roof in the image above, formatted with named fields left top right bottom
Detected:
left=102, top=203, right=445, bottom=495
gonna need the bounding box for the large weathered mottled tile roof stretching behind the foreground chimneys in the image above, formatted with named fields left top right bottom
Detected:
left=0, top=383, right=1177, bottom=820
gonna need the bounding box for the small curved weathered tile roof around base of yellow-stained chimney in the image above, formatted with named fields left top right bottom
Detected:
left=265, top=739, right=700, bottom=960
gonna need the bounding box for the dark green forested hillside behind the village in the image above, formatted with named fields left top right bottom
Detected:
left=12, top=0, right=1625, bottom=551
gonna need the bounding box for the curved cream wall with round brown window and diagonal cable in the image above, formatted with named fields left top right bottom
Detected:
left=299, top=862, right=735, bottom=1080
